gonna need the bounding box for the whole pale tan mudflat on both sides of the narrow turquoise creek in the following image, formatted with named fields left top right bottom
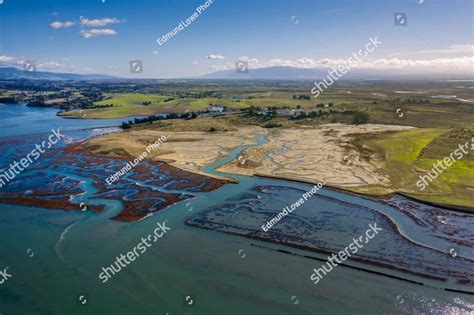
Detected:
left=85, top=123, right=414, bottom=188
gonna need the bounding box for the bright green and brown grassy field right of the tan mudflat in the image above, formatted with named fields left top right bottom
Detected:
left=356, top=129, right=474, bottom=208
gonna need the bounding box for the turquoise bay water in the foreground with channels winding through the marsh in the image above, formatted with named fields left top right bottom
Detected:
left=0, top=107, right=474, bottom=315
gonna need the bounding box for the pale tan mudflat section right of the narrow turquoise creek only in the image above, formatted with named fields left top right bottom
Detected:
left=218, top=124, right=413, bottom=187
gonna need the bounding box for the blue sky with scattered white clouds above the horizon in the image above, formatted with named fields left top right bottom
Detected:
left=0, top=0, right=474, bottom=78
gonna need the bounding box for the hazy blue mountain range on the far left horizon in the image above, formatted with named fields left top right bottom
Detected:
left=0, top=67, right=118, bottom=81
